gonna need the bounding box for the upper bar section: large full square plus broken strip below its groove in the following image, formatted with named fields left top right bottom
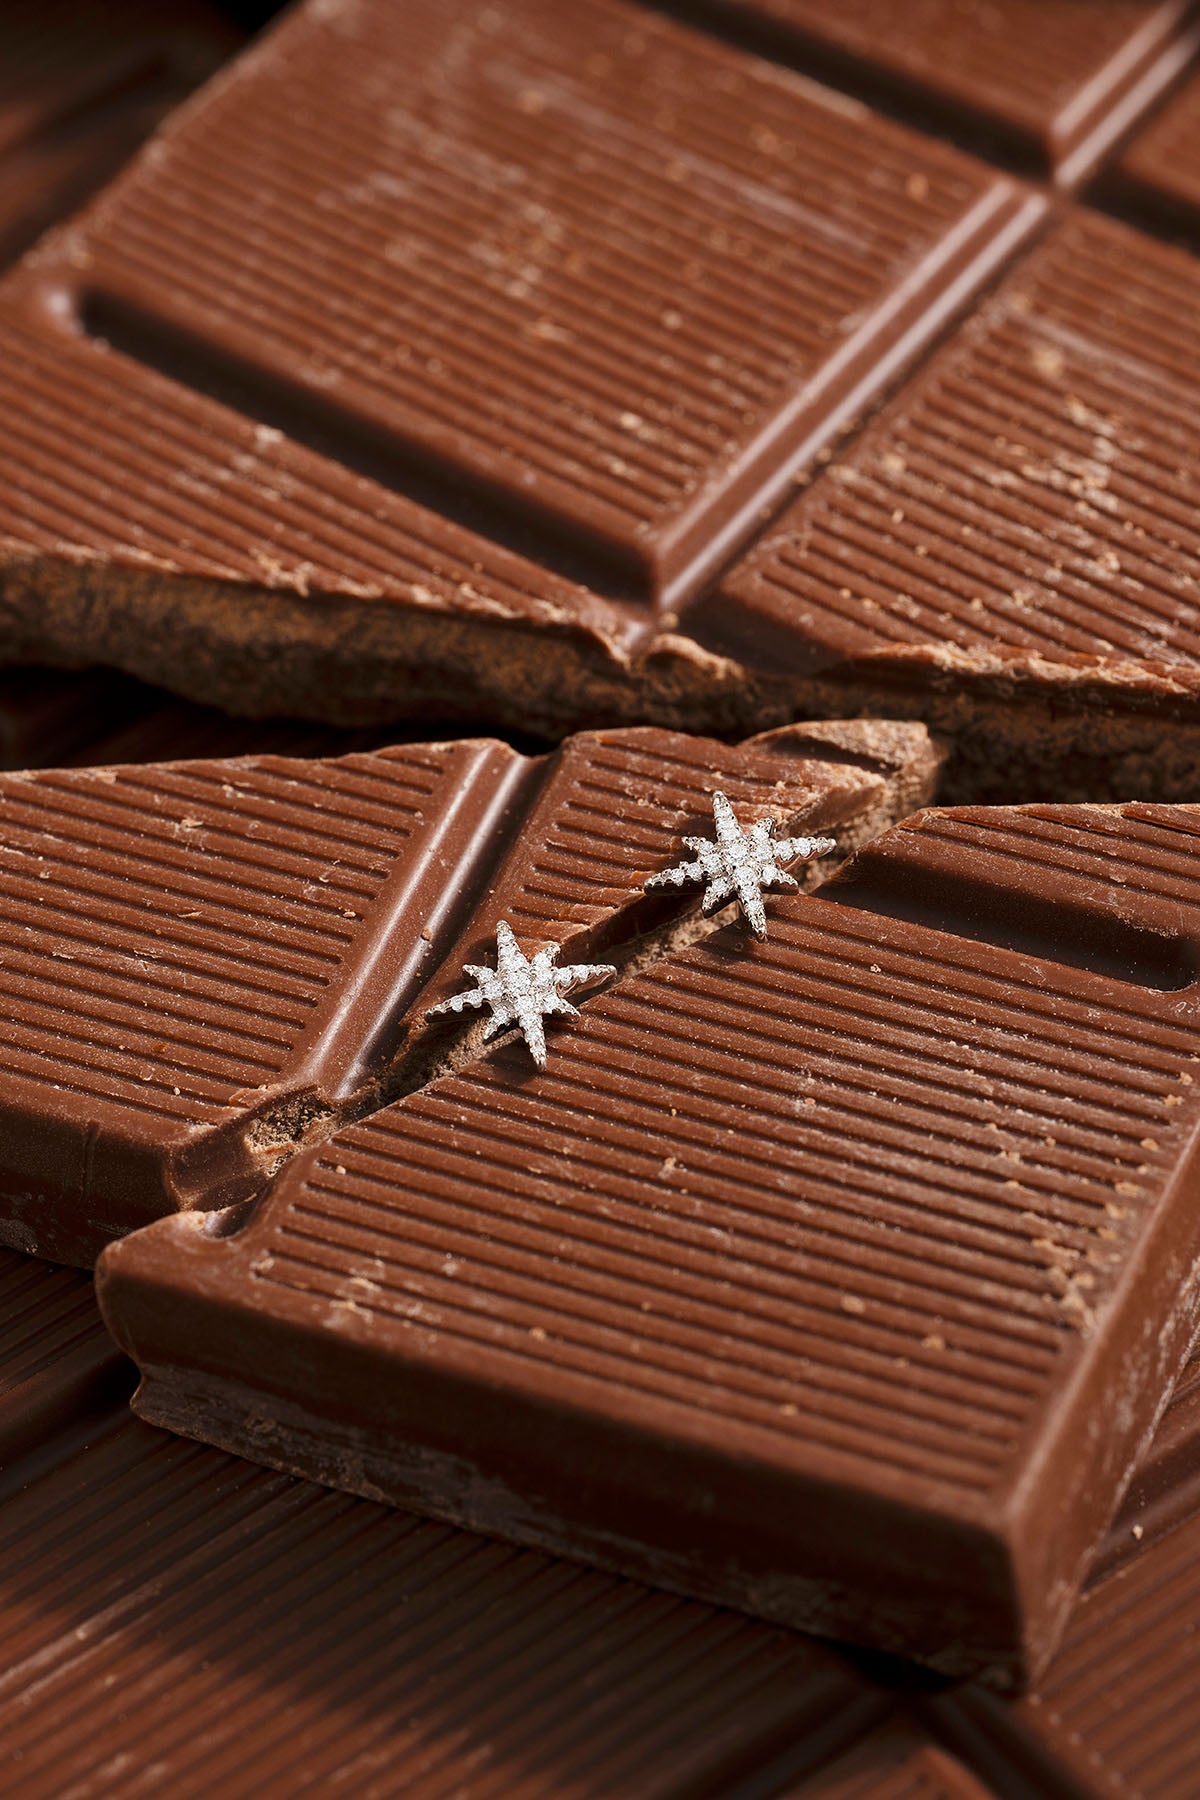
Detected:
left=0, top=0, right=1043, bottom=729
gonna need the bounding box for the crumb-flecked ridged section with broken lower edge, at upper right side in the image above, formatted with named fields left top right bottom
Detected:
left=685, top=211, right=1200, bottom=799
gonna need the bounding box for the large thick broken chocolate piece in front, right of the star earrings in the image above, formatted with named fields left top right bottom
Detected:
left=103, top=806, right=1200, bottom=1672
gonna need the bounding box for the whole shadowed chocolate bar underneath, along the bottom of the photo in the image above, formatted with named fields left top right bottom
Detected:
left=0, top=1216, right=1200, bottom=1800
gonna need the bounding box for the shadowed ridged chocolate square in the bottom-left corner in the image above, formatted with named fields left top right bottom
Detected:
left=0, top=1422, right=882, bottom=1800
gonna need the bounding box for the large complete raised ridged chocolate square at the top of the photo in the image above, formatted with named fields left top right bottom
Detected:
left=56, top=0, right=1013, bottom=594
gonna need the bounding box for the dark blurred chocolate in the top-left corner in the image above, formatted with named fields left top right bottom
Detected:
left=0, top=0, right=239, bottom=263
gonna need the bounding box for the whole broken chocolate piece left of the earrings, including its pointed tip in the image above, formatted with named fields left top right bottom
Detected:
left=0, top=724, right=937, bottom=1265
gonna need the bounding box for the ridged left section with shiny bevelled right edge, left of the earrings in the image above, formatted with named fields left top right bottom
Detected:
left=0, top=742, right=522, bottom=1262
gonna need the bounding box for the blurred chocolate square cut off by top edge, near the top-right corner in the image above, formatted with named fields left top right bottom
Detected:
left=690, top=0, right=1196, bottom=187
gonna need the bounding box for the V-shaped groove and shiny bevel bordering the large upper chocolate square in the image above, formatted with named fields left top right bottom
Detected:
left=37, top=175, right=1052, bottom=622
